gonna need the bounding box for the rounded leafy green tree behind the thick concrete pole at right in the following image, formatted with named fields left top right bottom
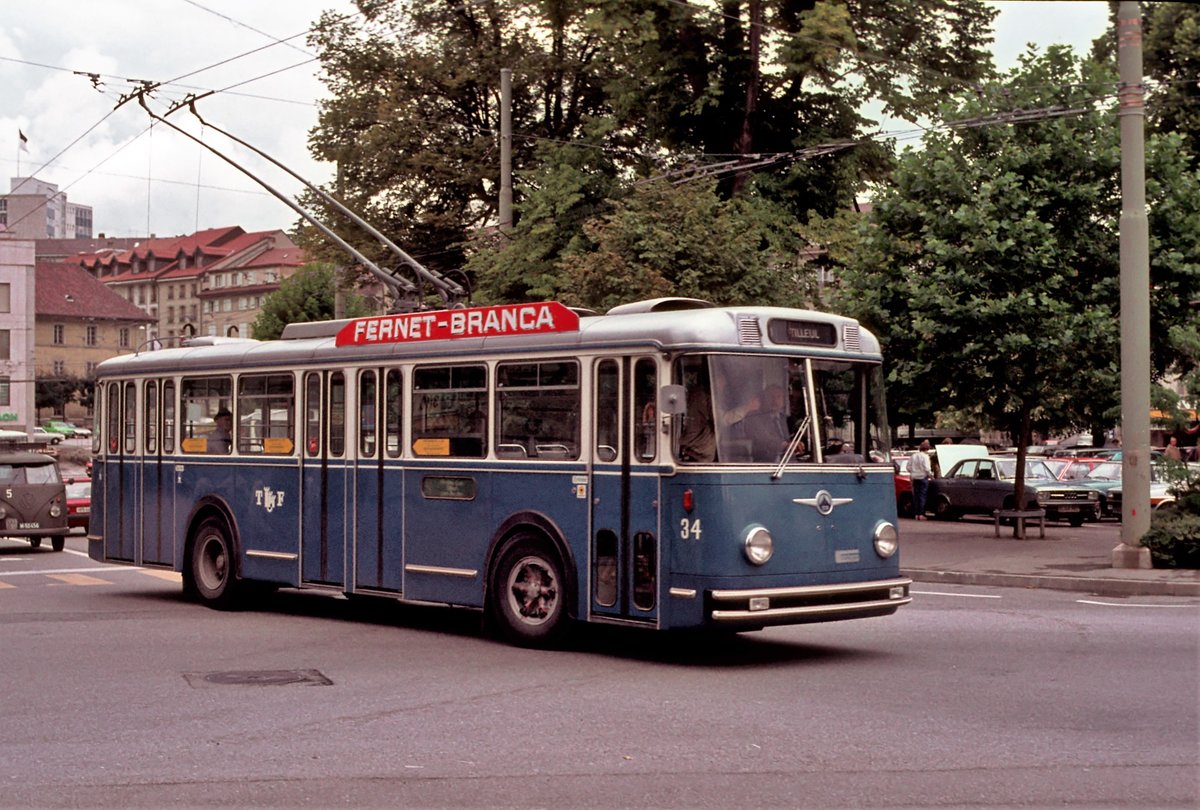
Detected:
left=839, top=47, right=1200, bottom=494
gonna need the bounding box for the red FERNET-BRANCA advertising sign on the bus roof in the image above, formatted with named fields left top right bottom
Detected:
left=335, top=301, right=580, bottom=346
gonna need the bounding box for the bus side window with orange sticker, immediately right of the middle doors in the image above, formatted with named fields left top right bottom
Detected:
left=412, top=366, right=487, bottom=458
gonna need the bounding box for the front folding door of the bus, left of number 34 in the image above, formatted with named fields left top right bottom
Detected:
left=588, top=356, right=665, bottom=623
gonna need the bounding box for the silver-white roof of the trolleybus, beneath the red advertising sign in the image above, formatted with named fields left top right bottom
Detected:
left=97, top=301, right=882, bottom=377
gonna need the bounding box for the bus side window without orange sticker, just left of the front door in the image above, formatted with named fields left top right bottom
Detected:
left=496, top=360, right=581, bottom=461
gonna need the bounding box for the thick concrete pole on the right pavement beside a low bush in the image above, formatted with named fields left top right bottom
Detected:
left=1112, top=0, right=1151, bottom=568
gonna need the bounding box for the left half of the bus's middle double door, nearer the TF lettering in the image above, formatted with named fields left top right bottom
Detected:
left=300, top=371, right=354, bottom=586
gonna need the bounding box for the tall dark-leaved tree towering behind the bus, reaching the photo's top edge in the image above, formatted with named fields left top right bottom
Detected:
left=300, top=0, right=995, bottom=299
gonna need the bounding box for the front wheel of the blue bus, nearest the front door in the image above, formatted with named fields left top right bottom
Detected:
left=491, top=535, right=568, bottom=647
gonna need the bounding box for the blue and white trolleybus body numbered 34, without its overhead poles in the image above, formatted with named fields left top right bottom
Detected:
left=89, top=299, right=910, bottom=644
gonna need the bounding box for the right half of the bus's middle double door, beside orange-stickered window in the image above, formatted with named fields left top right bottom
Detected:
left=352, top=368, right=403, bottom=592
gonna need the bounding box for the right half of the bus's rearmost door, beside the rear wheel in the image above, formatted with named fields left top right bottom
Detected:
left=138, top=379, right=175, bottom=564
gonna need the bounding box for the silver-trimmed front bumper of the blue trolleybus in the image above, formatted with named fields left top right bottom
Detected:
left=706, top=578, right=912, bottom=628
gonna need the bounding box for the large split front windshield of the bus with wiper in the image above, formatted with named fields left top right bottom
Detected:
left=673, top=354, right=890, bottom=464
